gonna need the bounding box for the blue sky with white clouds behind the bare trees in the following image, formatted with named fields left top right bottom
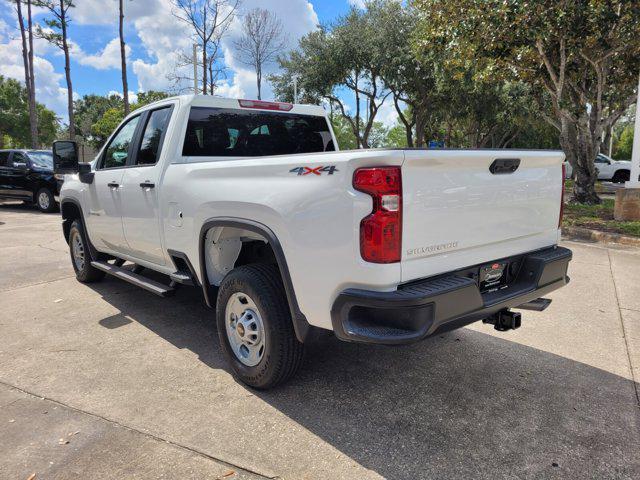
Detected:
left=0, top=0, right=395, bottom=125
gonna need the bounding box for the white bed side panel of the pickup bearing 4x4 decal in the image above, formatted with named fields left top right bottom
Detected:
left=161, top=150, right=404, bottom=328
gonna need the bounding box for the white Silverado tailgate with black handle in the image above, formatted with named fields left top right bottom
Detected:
left=402, top=150, right=564, bottom=282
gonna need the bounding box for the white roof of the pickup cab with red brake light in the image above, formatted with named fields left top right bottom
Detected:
left=143, top=95, right=326, bottom=117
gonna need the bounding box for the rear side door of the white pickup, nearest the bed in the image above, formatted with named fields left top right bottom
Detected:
left=121, top=105, right=173, bottom=265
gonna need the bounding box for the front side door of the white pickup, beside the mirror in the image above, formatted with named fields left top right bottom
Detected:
left=86, top=115, right=140, bottom=254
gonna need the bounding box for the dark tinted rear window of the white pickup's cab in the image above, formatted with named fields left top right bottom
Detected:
left=182, top=107, right=335, bottom=157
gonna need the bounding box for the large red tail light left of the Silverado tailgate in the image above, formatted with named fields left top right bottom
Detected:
left=353, top=167, right=402, bottom=263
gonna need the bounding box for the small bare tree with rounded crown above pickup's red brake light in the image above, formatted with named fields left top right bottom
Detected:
left=235, top=8, right=286, bottom=100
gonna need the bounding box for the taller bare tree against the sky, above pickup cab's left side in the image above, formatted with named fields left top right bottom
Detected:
left=172, top=0, right=240, bottom=95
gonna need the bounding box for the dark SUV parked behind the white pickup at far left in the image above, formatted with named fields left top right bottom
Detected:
left=0, top=150, right=62, bottom=212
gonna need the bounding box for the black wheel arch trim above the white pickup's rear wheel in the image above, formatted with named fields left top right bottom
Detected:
left=198, top=217, right=310, bottom=342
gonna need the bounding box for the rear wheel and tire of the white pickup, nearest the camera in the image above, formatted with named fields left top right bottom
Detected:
left=216, top=264, right=304, bottom=389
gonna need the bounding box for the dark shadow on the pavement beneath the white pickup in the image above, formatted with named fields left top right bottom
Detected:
left=92, top=280, right=640, bottom=480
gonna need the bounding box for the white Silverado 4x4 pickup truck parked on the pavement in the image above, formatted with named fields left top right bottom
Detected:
left=53, top=96, right=571, bottom=388
